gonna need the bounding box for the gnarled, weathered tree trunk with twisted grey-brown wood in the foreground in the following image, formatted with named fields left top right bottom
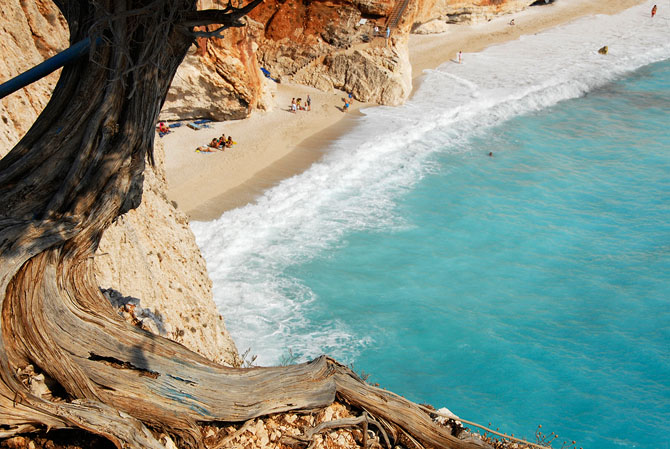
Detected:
left=0, top=0, right=486, bottom=448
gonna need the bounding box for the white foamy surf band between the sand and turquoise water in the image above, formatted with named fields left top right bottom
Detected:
left=192, top=2, right=670, bottom=365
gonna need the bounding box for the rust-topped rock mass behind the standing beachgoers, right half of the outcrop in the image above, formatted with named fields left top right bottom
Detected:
left=252, top=0, right=411, bottom=105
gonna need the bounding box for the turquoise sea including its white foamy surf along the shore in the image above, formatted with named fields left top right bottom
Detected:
left=192, top=2, right=670, bottom=449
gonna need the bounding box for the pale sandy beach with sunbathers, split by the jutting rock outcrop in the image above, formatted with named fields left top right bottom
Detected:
left=160, top=0, right=643, bottom=221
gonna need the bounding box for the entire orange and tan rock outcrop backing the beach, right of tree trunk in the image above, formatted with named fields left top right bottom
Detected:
left=161, top=0, right=411, bottom=110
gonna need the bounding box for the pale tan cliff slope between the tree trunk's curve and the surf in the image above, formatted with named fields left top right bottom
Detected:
left=95, top=142, right=242, bottom=364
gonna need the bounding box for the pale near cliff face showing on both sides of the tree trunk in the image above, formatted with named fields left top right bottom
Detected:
left=0, top=0, right=237, bottom=364
